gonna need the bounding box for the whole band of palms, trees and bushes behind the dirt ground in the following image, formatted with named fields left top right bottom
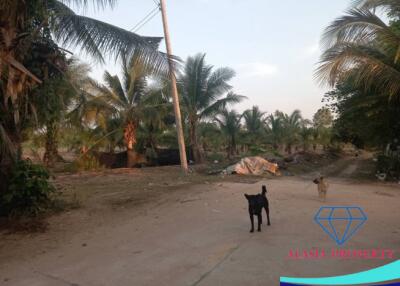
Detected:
left=0, top=0, right=400, bottom=216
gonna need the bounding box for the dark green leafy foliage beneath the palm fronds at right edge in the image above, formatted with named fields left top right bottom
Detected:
left=325, top=78, right=400, bottom=148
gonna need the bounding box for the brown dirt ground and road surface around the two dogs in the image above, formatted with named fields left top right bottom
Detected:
left=0, top=158, right=400, bottom=286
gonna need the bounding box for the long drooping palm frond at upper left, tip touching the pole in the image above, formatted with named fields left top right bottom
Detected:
left=49, top=0, right=169, bottom=73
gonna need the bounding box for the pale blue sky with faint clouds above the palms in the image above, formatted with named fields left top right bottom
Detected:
left=73, top=0, right=351, bottom=119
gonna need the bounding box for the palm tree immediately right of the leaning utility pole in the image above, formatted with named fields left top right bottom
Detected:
left=178, top=54, right=245, bottom=163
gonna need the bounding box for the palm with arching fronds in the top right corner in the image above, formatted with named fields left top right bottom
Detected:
left=316, top=0, right=400, bottom=99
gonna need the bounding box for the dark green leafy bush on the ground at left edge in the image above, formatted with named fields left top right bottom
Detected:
left=0, top=160, right=55, bottom=216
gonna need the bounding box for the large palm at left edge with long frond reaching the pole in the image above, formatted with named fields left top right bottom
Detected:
left=0, top=0, right=168, bottom=161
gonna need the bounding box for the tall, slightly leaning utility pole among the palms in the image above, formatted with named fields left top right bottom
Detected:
left=160, top=0, right=188, bottom=173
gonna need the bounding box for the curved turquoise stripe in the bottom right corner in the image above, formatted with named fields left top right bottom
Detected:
left=280, top=260, right=400, bottom=285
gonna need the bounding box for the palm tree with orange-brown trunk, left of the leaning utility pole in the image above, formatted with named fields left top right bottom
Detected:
left=89, top=56, right=170, bottom=167
